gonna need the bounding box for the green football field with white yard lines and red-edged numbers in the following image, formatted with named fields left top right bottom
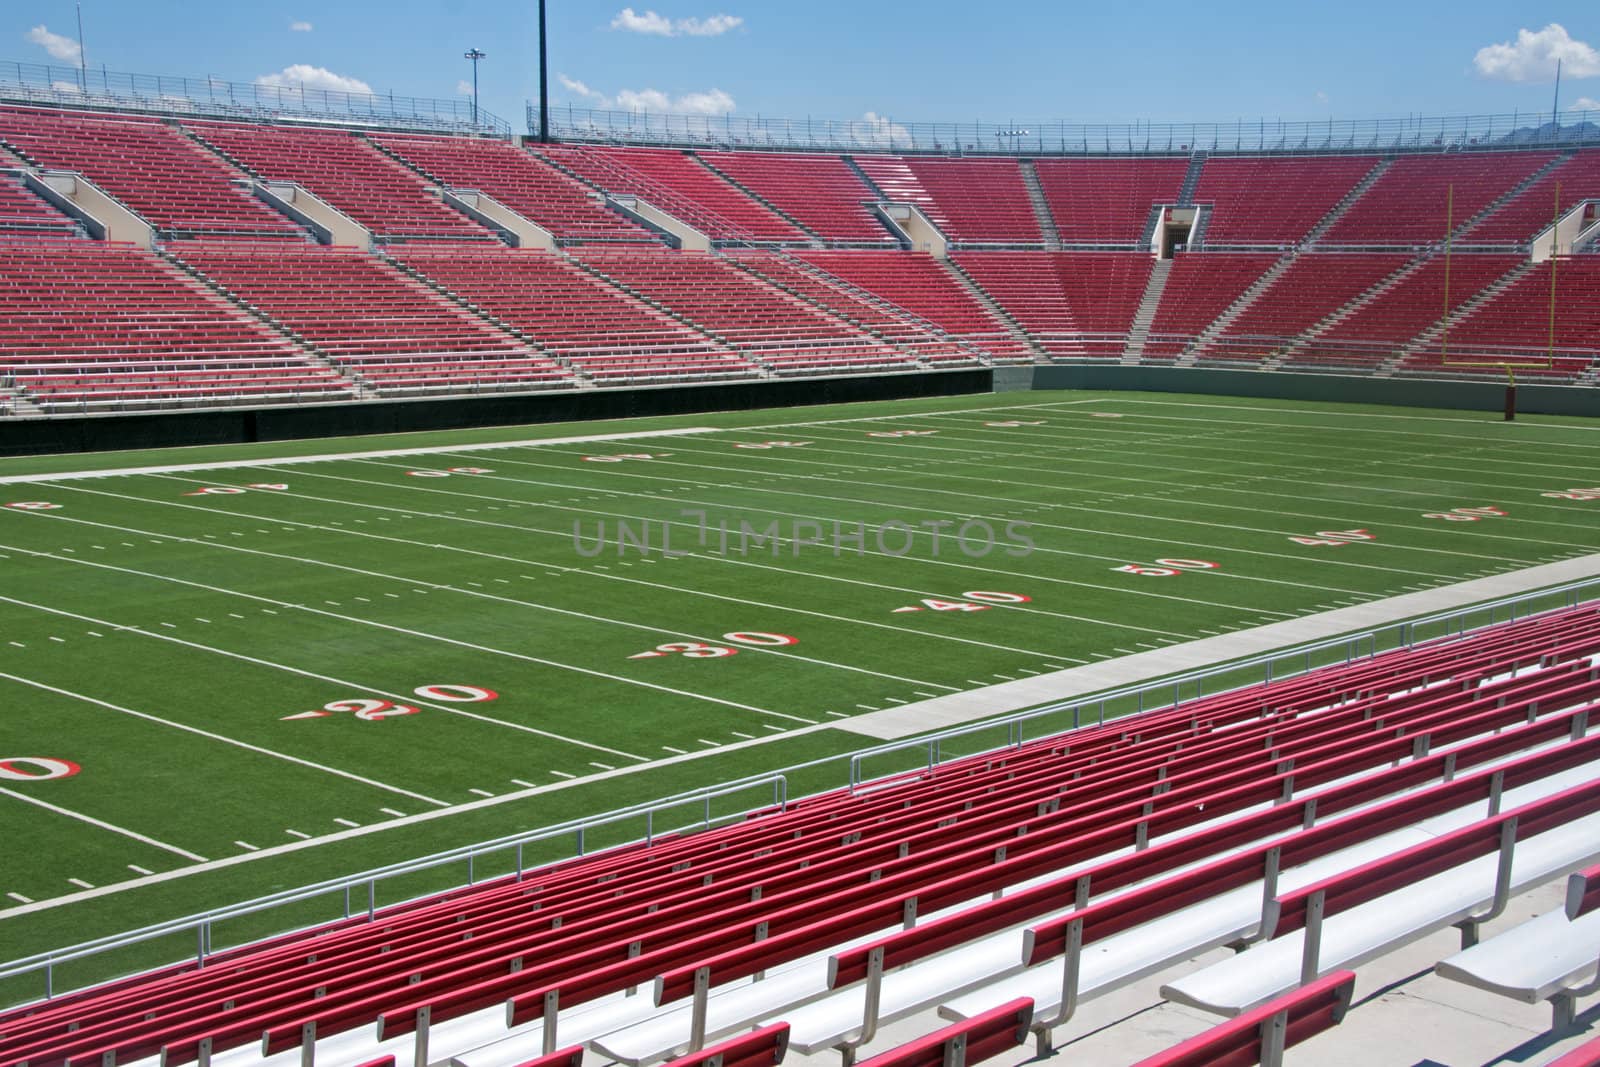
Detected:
left=0, top=392, right=1600, bottom=1000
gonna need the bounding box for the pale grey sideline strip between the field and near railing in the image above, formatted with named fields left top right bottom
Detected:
left=834, top=553, right=1600, bottom=741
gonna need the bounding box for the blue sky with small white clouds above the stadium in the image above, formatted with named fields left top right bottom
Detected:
left=9, top=0, right=1600, bottom=130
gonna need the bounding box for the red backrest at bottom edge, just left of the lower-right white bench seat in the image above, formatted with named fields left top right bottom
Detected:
left=1134, top=971, right=1355, bottom=1067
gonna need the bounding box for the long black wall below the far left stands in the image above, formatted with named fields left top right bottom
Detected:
left=0, top=368, right=994, bottom=456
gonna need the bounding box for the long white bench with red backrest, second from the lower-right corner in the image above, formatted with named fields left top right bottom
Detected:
left=1162, top=779, right=1600, bottom=1016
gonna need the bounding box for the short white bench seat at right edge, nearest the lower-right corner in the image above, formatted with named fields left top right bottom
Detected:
left=1435, top=865, right=1600, bottom=1030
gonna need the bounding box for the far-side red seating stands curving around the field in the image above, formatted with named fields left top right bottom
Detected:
left=0, top=99, right=1600, bottom=411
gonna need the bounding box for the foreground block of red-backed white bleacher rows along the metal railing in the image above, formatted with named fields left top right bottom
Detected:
left=0, top=606, right=1600, bottom=1067
